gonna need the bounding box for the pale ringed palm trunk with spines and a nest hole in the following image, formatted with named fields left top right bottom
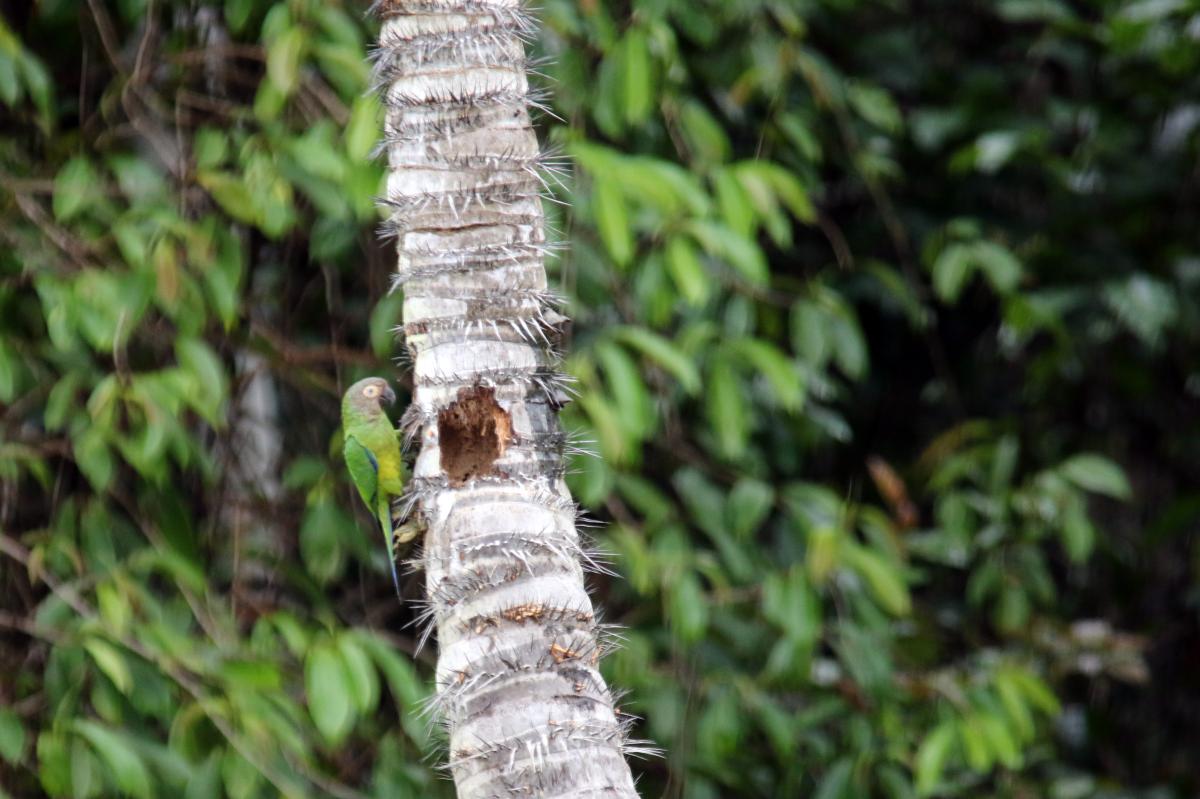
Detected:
left=377, top=0, right=637, bottom=798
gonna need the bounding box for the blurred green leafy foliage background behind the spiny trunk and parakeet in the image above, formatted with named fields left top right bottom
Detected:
left=0, top=0, right=1200, bottom=799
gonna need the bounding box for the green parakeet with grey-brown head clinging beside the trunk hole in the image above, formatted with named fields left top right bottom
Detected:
left=342, top=378, right=404, bottom=596
